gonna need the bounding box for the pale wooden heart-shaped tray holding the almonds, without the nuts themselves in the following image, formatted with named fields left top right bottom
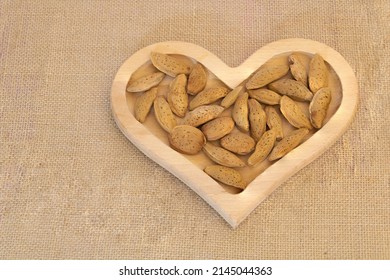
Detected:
left=111, top=38, right=358, bottom=228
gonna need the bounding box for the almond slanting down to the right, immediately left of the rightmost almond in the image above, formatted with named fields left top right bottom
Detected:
left=280, top=96, right=312, bottom=129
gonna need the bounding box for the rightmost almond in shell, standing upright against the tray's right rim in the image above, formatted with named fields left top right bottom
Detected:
left=309, top=87, right=332, bottom=128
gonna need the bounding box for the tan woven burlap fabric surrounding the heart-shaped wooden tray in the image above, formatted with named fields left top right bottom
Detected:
left=0, top=0, right=390, bottom=259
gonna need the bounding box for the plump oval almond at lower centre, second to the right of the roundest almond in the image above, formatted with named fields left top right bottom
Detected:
left=220, top=131, right=256, bottom=155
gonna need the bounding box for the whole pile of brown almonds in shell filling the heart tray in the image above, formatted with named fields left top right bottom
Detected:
left=127, top=52, right=331, bottom=189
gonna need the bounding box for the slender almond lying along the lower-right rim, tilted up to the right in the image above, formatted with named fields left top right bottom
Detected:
left=268, top=128, right=309, bottom=161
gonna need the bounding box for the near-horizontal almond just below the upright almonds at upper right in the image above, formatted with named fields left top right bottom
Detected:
left=268, top=79, right=313, bottom=101
